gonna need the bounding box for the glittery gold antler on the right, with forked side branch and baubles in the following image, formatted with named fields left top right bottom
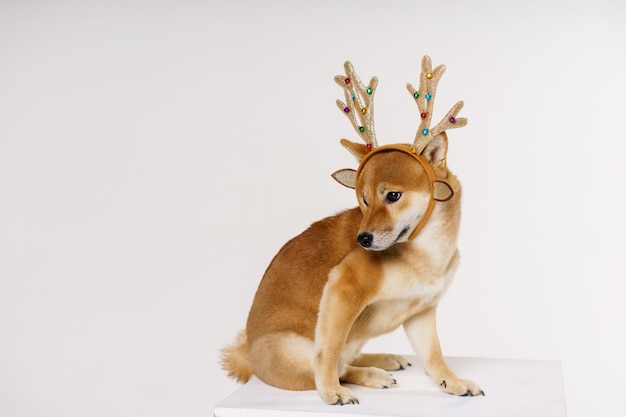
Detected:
left=406, top=55, right=467, bottom=154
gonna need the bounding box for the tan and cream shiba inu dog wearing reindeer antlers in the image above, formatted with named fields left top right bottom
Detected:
left=222, top=56, right=484, bottom=405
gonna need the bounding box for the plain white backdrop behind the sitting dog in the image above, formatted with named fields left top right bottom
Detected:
left=0, top=0, right=626, bottom=417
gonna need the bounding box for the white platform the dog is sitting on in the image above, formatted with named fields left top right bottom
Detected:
left=214, top=355, right=567, bottom=417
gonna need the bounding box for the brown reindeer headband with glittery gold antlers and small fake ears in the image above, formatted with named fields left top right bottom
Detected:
left=332, top=55, right=467, bottom=239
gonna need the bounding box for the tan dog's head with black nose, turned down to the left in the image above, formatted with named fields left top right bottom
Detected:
left=342, top=133, right=454, bottom=251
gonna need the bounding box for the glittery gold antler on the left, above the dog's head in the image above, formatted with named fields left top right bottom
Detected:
left=335, top=61, right=378, bottom=149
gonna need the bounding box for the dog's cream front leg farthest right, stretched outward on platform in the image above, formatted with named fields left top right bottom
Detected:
left=403, top=307, right=485, bottom=396
